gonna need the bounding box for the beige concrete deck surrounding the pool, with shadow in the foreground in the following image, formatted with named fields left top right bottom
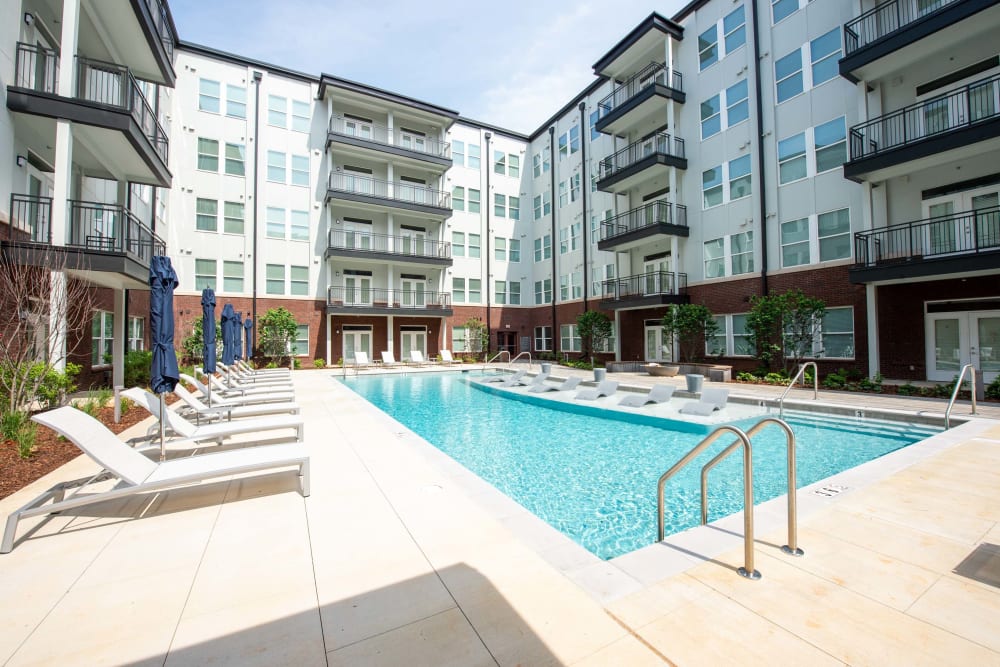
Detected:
left=0, top=367, right=1000, bottom=665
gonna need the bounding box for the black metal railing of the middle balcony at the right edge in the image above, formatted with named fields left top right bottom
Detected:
left=851, top=75, right=1000, bottom=160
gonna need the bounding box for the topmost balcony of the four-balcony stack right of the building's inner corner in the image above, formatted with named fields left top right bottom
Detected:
left=594, top=63, right=686, bottom=134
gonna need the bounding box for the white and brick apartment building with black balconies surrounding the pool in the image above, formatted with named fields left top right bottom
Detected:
left=0, top=0, right=1000, bottom=380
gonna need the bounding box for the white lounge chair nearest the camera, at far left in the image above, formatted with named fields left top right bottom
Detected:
left=0, top=407, right=309, bottom=553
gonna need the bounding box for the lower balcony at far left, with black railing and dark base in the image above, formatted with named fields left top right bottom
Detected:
left=2, top=194, right=167, bottom=288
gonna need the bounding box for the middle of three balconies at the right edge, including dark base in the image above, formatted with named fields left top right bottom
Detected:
left=844, top=75, right=1000, bottom=182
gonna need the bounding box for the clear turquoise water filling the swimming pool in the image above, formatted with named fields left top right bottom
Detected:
left=345, top=373, right=937, bottom=559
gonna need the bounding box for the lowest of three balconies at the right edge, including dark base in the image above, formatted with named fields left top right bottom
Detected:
left=850, top=206, right=1000, bottom=283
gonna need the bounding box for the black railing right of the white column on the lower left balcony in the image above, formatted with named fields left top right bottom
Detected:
left=66, top=200, right=167, bottom=264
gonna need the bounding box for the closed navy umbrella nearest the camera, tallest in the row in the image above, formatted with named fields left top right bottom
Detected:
left=149, top=255, right=180, bottom=461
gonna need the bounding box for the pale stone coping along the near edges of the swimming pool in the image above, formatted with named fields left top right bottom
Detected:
left=334, top=376, right=996, bottom=605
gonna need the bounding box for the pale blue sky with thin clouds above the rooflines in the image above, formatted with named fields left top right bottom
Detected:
left=169, top=0, right=686, bottom=134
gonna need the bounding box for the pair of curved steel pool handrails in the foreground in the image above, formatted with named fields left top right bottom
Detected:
left=656, top=417, right=804, bottom=579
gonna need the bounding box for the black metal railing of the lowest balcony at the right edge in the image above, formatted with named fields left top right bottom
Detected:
left=854, top=206, right=1000, bottom=268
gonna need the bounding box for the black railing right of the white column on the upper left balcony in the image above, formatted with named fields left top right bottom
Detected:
left=76, top=56, right=168, bottom=164
